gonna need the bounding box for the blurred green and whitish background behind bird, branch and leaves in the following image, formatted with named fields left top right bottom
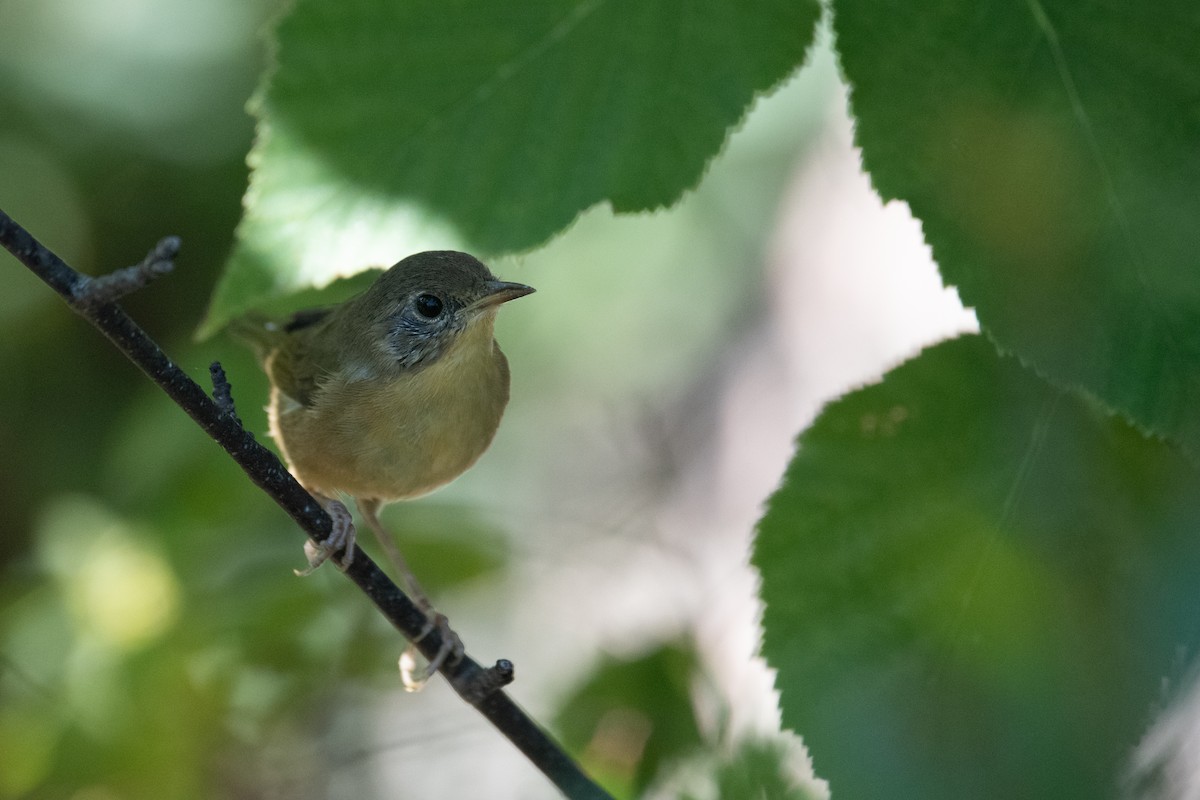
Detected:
left=0, top=0, right=974, bottom=800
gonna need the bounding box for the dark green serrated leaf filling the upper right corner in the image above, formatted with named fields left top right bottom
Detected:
left=833, top=0, right=1200, bottom=455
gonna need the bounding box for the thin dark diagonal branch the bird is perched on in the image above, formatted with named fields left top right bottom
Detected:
left=0, top=211, right=611, bottom=800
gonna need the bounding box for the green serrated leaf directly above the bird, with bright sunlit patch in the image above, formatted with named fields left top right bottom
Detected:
left=202, top=0, right=820, bottom=333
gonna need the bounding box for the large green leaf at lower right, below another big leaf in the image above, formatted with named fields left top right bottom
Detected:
left=754, top=336, right=1200, bottom=800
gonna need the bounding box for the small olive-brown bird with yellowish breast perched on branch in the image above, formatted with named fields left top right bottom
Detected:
left=233, top=251, right=533, bottom=685
